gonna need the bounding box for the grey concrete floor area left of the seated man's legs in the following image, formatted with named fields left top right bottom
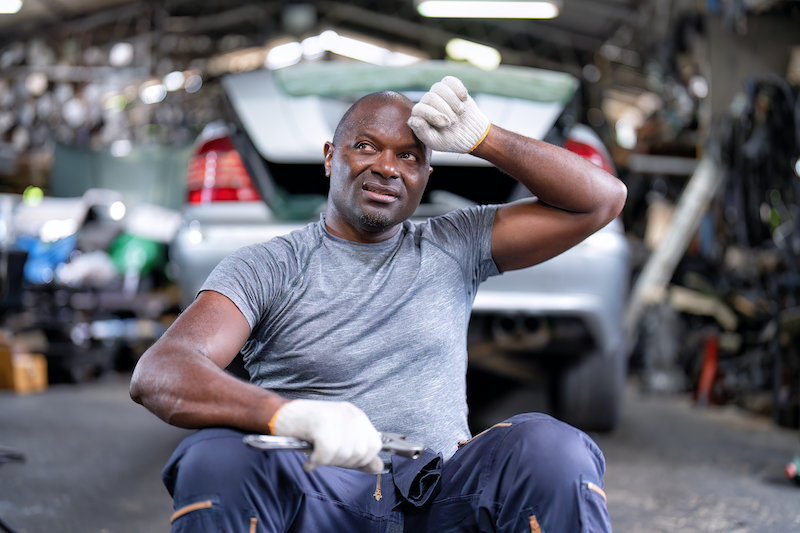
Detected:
left=0, top=374, right=190, bottom=533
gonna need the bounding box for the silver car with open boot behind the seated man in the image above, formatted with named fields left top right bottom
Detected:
left=170, top=61, right=630, bottom=431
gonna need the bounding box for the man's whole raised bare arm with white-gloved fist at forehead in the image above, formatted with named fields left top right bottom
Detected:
left=408, top=76, right=627, bottom=271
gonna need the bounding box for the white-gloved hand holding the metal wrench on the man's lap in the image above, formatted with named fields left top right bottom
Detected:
left=269, top=400, right=383, bottom=474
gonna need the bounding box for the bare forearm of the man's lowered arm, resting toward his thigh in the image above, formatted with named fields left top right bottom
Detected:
left=130, top=346, right=286, bottom=433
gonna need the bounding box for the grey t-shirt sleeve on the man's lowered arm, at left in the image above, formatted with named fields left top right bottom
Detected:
left=200, top=239, right=287, bottom=331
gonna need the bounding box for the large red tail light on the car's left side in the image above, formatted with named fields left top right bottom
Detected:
left=186, top=137, right=260, bottom=204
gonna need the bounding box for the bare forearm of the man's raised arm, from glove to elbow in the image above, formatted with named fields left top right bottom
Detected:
left=471, top=125, right=627, bottom=223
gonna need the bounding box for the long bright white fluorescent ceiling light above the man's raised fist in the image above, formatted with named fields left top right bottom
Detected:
left=416, top=0, right=560, bottom=19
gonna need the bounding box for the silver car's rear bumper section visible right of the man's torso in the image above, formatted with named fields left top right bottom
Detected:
left=470, top=221, right=630, bottom=354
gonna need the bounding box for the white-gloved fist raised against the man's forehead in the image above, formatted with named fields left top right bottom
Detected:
left=408, top=76, right=491, bottom=154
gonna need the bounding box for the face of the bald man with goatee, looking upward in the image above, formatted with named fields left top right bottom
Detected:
left=325, top=95, right=432, bottom=242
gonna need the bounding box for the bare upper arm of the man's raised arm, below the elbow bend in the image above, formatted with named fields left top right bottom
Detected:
left=492, top=199, right=597, bottom=272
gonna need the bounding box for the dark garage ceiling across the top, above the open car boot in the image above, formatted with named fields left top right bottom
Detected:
left=0, top=0, right=800, bottom=88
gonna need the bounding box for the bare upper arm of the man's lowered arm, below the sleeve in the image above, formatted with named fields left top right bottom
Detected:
left=158, top=291, right=250, bottom=368
